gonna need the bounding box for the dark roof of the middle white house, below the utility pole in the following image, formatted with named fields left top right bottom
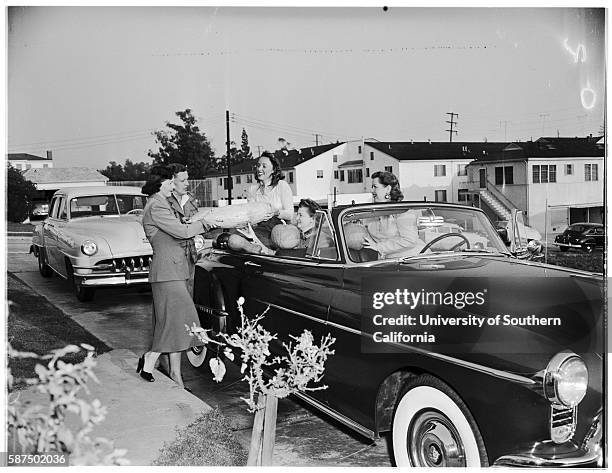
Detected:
left=366, top=141, right=508, bottom=161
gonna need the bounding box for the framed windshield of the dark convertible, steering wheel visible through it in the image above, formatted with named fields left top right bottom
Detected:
left=341, top=204, right=509, bottom=262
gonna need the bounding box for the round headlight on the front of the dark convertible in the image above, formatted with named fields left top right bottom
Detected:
left=544, top=351, right=589, bottom=407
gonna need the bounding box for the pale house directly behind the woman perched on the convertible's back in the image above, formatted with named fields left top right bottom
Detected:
left=205, top=143, right=343, bottom=205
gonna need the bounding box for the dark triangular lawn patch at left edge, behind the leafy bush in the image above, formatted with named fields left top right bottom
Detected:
left=6, top=273, right=110, bottom=389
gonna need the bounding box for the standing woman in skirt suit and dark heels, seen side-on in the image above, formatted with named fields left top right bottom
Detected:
left=136, top=165, right=209, bottom=387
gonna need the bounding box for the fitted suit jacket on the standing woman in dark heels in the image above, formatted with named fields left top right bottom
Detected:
left=142, top=193, right=205, bottom=282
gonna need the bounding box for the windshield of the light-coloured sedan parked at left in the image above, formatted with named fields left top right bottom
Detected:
left=70, top=194, right=145, bottom=218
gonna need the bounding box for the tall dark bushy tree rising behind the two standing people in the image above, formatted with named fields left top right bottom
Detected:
left=148, top=108, right=215, bottom=179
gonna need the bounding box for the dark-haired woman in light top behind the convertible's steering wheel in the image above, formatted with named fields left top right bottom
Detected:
left=364, top=171, right=424, bottom=259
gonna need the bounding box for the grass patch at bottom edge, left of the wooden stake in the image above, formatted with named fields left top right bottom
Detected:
left=153, top=408, right=247, bottom=466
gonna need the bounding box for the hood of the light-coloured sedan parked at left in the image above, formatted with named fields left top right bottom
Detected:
left=69, top=215, right=153, bottom=257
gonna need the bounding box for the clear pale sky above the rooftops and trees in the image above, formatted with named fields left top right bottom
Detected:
left=6, top=6, right=605, bottom=169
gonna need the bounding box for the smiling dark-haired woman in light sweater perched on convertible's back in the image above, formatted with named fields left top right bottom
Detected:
left=228, top=151, right=293, bottom=252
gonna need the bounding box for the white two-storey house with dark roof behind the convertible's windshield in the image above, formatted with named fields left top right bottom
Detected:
left=333, top=141, right=507, bottom=203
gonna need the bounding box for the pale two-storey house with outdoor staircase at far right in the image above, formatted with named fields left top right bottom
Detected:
left=468, top=136, right=605, bottom=235
